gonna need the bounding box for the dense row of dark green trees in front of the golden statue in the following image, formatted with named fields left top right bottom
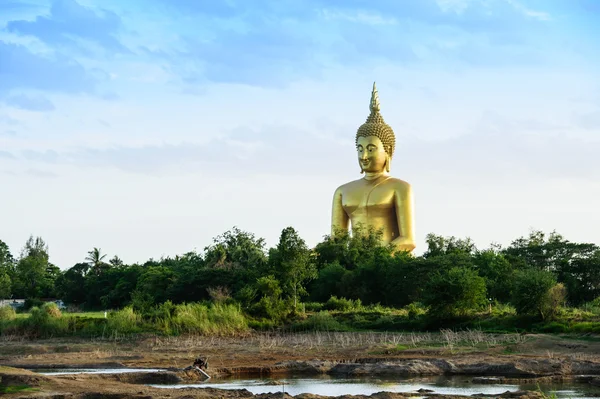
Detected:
left=0, top=227, right=600, bottom=321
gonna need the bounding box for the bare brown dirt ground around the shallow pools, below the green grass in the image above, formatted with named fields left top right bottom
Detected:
left=0, top=333, right=600, bottom=399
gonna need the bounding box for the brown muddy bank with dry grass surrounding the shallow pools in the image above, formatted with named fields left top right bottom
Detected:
left=0, top=331, right=600, bottom=398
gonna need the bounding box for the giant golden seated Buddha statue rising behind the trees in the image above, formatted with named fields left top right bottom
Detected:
left=331, top=83, right=415, bottom=252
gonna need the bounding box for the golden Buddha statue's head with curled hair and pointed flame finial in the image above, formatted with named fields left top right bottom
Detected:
left=356, top=83, right=396, bottom=173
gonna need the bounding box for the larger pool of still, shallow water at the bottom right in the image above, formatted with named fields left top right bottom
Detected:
left=151, top=376, right=600, bottom=399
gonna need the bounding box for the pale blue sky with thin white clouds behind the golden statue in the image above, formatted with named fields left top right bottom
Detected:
left=0, top=0, right=600, bottom=268
